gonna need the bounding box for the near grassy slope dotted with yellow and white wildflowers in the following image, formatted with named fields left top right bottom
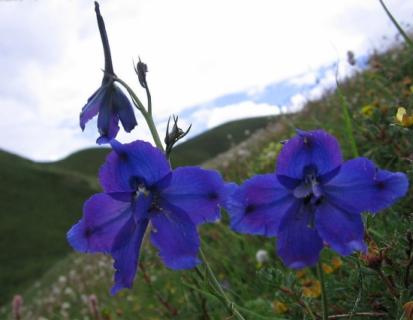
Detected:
left=0, top=42, right=413, bottom=320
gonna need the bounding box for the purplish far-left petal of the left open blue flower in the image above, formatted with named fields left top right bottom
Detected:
left=67, top=193, right=132, bottom=253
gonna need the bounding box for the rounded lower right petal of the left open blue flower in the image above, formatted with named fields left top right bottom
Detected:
left=151, top=207, right=201, bottom=270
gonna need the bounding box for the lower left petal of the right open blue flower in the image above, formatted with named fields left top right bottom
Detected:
left=277, top=201, right=323, bottom=269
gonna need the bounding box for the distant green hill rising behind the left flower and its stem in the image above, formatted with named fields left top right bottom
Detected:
left=49, top=117, right=276, bottom=177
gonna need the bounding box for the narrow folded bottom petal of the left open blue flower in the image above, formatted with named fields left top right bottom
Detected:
left=111, top=196, right=152, bottom=295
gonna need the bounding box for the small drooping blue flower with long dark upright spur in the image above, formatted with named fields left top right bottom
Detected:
left=80, top=2, right=137, bottom=144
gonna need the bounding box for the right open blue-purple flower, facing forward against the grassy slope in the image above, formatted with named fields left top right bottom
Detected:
left=228, top=130, right=408, bottom=268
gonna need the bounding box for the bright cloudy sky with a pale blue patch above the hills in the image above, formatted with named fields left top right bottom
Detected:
left=0, top=0, right=413, bottom=161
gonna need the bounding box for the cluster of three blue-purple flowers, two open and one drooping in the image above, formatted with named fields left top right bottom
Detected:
left=67, top=1, right=408, bottom=294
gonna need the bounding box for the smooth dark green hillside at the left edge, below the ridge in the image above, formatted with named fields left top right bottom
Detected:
left=0, top=152, right=95, bottom=305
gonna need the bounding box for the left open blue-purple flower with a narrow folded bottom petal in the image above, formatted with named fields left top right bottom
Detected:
left=67, top=140, right=232, bottom=294
